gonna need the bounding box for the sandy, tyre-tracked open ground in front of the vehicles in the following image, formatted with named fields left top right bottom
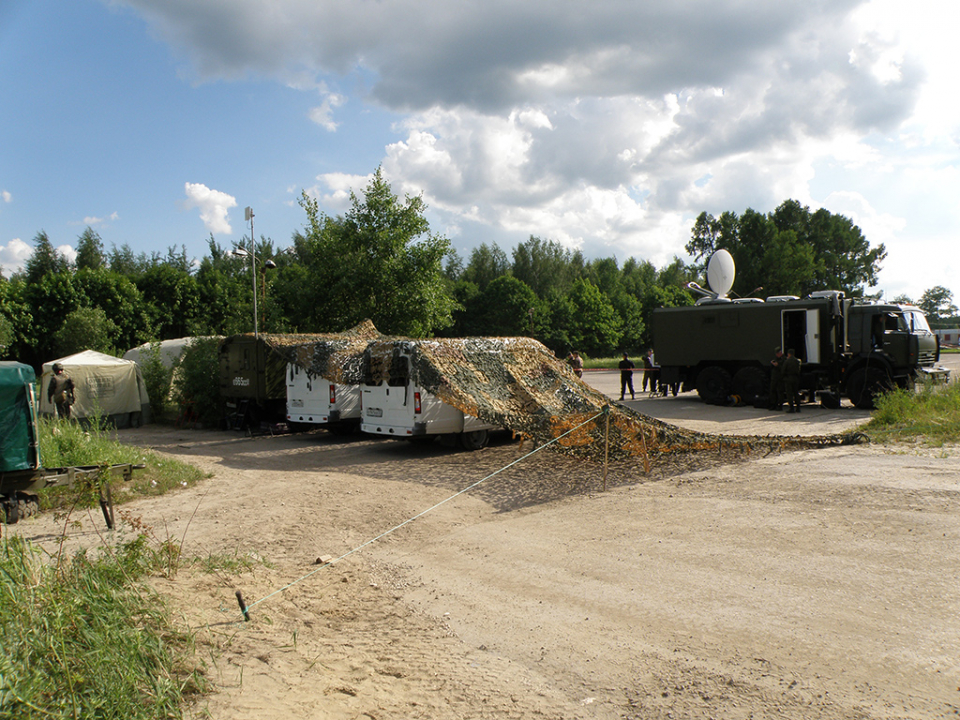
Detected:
left=6, top=362, right=960, bottom=720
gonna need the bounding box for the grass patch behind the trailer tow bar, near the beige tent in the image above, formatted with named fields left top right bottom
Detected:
left=37, top=418, right=204, bottom=508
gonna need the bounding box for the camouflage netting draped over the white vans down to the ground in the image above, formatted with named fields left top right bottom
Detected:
left=266, top=324, right=862, bottom=462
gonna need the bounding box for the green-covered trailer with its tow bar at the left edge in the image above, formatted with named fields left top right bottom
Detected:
left=0, top=361, right=143, bottom=528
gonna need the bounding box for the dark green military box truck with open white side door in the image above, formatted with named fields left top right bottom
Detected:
left=652, top=291, right=950, bottom=409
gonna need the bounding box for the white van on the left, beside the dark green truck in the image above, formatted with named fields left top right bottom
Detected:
left=287, top=363, right=361, bottom=434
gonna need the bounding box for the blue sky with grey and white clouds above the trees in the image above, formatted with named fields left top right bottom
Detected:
left=0, top=0, right=960, bottom=302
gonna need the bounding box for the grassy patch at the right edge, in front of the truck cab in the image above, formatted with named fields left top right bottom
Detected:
left=863, top=382, right=960, bottom=446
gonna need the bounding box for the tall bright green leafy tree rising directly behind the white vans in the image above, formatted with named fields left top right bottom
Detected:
left=295, top=168, right=455, bottom=337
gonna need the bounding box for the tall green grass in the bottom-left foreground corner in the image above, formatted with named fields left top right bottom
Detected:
left=0, top=535, right=203, bottom=720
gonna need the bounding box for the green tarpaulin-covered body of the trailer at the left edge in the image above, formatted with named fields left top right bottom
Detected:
left=0, top=361, right=40, bottom=472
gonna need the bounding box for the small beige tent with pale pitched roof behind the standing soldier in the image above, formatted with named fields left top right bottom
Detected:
left=40, top=350, right=150, bottom=428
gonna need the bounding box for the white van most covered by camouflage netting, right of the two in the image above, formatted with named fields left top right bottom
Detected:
left=360, top=358, right=500, bottom=450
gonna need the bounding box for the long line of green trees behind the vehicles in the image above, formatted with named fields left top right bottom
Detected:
left=0, top=169, right=944, bottom=367
